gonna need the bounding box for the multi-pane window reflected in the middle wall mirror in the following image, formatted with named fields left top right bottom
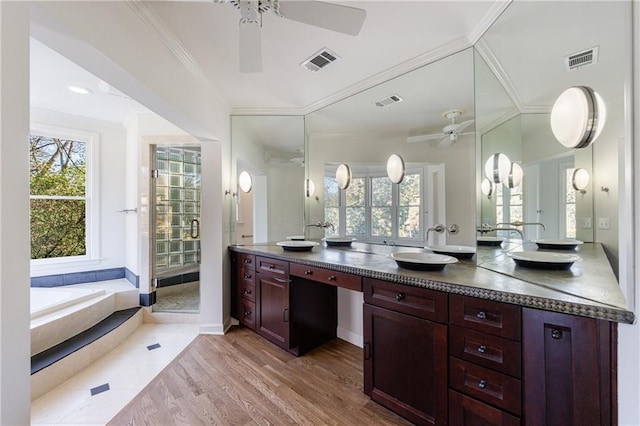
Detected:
left=324, top=170, right=423, bottom=244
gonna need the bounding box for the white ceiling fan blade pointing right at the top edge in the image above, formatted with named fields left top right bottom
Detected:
left=279, top=1, right=367, bottom=36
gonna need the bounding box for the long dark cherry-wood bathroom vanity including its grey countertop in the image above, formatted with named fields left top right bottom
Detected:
left=230, top=243, right=634, bottom=425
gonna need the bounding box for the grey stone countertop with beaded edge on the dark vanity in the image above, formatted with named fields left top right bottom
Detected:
left=229, top=242, right=635, bottom=324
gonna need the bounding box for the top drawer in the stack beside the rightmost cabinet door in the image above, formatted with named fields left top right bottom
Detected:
left=449, top=294, right=522, bottom=341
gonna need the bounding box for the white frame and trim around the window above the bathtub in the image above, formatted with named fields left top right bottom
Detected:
left=31, top=108, right=129, bottom=276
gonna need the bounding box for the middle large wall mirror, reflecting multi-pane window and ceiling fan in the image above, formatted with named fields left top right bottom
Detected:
left=305, top=48, right=475, bottom=246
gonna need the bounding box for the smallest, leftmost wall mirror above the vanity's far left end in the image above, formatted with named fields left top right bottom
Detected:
left=227, top=115, right=305, bottom=244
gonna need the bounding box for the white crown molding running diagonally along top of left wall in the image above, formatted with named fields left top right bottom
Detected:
left=125, top=0, right=231, bottom=109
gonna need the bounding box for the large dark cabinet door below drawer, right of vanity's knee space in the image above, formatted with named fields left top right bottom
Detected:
left=364, top=303, right=447, bottom=425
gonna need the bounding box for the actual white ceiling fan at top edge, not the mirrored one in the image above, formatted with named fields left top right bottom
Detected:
left=220, top=0, right=367, bottom=73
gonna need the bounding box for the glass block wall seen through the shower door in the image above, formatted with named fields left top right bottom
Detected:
left=155, top=147, right=201, bottom=271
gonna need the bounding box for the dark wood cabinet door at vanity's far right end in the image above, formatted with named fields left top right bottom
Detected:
left=522, top=309, right=616, bottom=426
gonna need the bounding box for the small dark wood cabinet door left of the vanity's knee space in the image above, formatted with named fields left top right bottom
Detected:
left=256, top=274, right=289, bottom=349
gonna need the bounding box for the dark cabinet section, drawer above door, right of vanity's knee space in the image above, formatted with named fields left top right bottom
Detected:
left=364, top=278, right=448, bottom=425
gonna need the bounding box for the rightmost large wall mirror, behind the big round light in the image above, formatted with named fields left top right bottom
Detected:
left=475, top=2, right=632, bottom=282
